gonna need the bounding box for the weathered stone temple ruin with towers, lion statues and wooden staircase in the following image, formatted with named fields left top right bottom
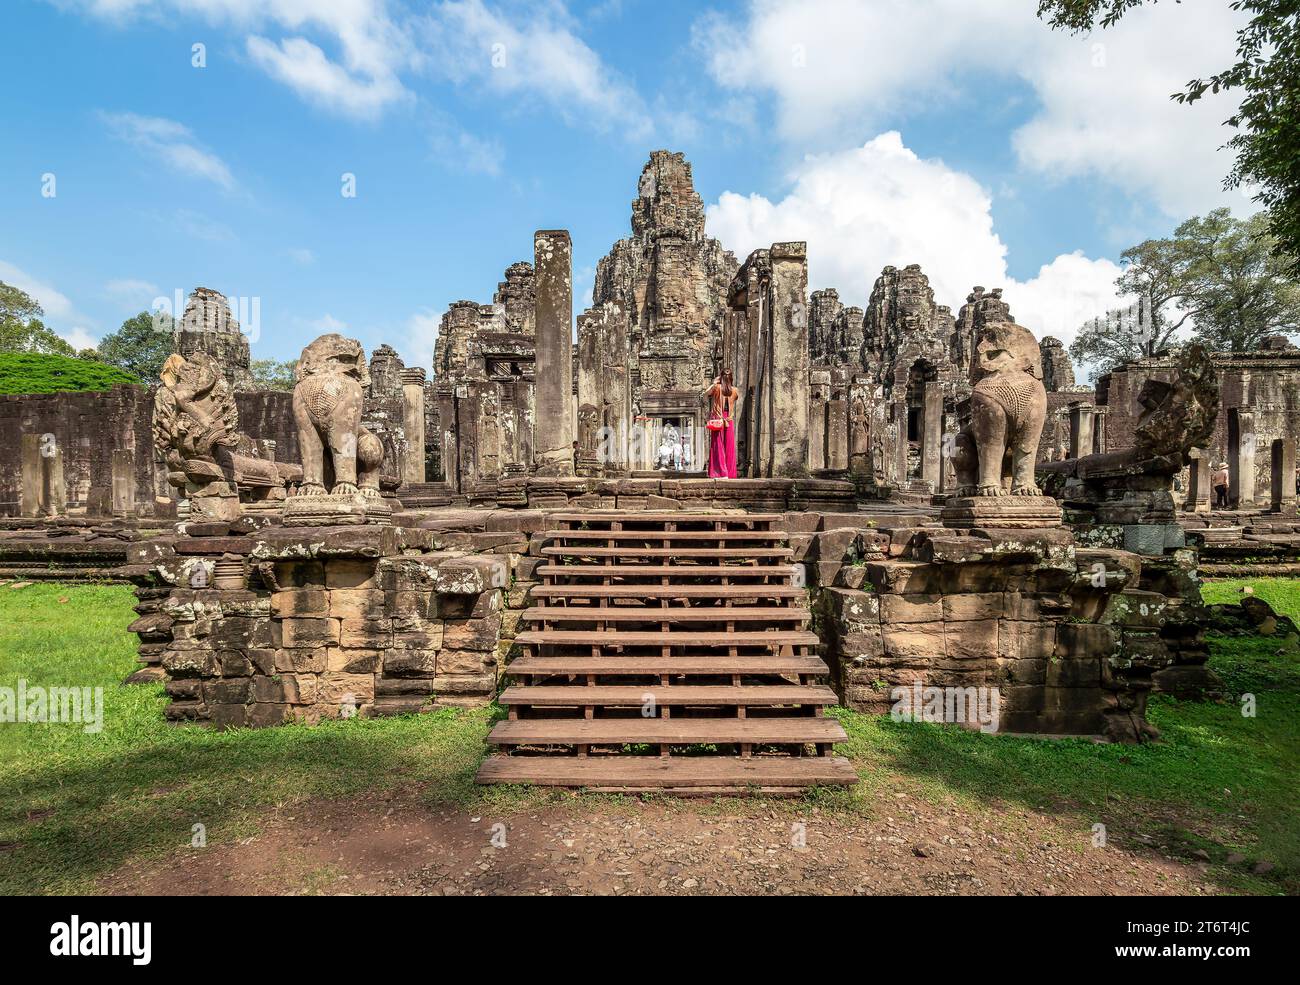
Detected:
left=0, top=151, right=1300, bottom=793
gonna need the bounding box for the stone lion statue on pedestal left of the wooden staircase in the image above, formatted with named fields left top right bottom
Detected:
left=294, top=333, right=384, bottom=499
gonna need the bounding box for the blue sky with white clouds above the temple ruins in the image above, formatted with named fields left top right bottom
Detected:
left=0, top=0, right=1248, bottom=365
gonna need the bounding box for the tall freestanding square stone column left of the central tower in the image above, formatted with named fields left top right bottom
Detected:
left=533, top=229, right=575, bottom=476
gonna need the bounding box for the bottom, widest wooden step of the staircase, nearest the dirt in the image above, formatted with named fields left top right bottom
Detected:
left=475, top=755, right=858, bottom=795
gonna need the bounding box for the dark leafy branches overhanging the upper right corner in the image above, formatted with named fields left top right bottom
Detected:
left=1039, top=0, right=1300, bottom=277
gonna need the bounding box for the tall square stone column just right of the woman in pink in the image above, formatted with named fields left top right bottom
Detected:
left=770, top=243, right=809, bottom=477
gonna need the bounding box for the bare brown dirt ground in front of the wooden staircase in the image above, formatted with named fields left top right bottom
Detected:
left=100, top=794, right=1222, bottom=895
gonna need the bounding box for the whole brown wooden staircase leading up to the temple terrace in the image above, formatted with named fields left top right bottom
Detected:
left=477, top=512, right=857, bottom=794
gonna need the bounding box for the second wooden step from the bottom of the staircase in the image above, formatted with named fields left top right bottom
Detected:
left=488, top=717, right=849, bottom=746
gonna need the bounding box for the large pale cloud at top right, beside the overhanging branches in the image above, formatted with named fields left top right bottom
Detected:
left=693, top=0, right=1247, bottom=217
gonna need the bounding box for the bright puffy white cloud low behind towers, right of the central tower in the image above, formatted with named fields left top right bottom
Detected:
left=706, top=131, right=1119, bottom=344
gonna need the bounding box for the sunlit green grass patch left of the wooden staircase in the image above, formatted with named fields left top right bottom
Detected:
left=0, top=585, right=512, bottom=894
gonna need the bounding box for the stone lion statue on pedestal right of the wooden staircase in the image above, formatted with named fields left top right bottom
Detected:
left=953, top=321, right=1048, bottom=496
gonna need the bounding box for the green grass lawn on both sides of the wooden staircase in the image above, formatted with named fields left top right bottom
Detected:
left=0, top=581, right=1300, bottom=893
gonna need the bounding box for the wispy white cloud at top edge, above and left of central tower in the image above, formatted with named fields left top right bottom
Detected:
left=417, top=0, right=653, bottom=139
